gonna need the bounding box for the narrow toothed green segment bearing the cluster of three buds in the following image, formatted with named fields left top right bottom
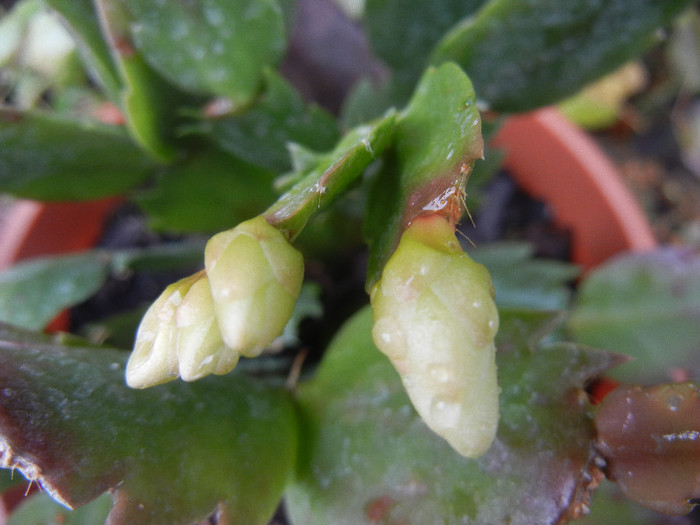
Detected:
left=265, top=110, right=396, bottom=239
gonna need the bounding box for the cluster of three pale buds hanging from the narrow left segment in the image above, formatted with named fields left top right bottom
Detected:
left=126, top=216, right=304, bottom=388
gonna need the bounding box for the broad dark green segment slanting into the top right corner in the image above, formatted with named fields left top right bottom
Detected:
left=432, top=0, right=692, bottom=112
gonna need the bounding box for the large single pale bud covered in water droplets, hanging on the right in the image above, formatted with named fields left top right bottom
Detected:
left=370, top=215, right=499, bottom=457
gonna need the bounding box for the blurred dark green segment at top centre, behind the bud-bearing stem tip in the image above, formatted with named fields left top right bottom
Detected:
left=364, top=0, right=485, bottom=102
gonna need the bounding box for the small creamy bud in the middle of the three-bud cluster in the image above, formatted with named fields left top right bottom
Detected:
left=175, top=272, right=239, bottom=381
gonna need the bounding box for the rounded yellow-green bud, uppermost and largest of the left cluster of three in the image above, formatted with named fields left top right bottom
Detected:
left=204, top=216, right=304, bottom=357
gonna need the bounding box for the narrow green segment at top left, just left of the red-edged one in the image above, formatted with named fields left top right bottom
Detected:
left=46, top=0, right=121, bottom=103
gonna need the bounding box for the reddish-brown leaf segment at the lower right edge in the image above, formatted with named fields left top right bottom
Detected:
left=595, top=382, right=700, bottom=515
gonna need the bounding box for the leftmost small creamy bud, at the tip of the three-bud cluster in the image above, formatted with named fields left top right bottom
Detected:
left=126, top=274, right=199, bottom=388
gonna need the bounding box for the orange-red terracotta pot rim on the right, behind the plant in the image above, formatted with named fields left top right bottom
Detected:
left=493, top=108, right=656, bottom=269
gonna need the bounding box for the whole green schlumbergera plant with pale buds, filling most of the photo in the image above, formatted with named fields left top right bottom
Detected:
left=0, top=0, right=700, bottom=525
